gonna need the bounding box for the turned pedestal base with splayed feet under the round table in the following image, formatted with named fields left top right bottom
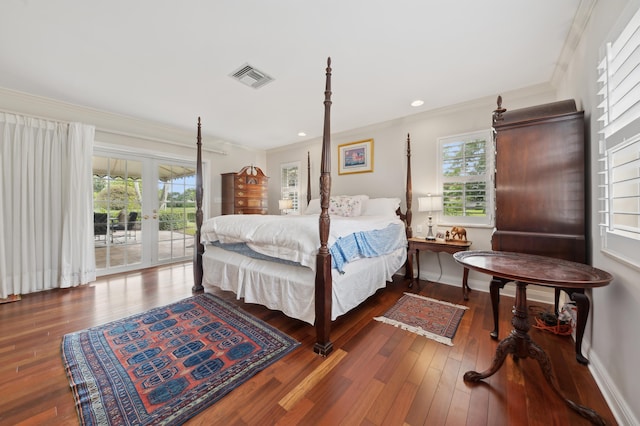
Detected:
left=464, top=282, right=606, bottom=425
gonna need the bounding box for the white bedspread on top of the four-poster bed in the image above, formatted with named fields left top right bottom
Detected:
left=201, top=215, right=406, bottom=270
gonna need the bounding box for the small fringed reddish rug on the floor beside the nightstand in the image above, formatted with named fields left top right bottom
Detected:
left=374, top=293, right=469, bottom=346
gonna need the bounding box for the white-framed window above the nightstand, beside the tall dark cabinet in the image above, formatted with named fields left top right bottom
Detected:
left=438, top=130, right=494, bottom=225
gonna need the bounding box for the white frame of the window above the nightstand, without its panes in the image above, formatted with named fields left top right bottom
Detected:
left=438, top=129, right=495, bottom=227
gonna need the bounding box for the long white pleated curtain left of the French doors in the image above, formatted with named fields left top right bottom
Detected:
left=0, top=112, right=96, bottom=298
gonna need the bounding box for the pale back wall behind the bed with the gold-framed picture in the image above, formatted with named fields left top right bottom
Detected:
left=267, top=85, right=556, bottom=303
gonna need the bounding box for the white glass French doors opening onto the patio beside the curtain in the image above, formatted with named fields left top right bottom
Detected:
left=93, top=148, right=196, bottom=275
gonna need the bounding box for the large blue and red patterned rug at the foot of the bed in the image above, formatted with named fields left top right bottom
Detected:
left=62, top=293, right=299, bottom=425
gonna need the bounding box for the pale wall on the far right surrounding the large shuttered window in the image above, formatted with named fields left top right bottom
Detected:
left=558, top=0, right=640, bottom=425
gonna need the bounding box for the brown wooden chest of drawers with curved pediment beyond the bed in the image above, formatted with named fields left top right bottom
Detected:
left=222, top=166, right=269, bottom=214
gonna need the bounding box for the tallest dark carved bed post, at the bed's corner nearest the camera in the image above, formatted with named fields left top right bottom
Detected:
left=313, top=58, right=333, bottom=356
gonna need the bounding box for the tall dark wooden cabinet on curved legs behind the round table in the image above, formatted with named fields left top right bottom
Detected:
left=491, top=96, right=589, bottom=363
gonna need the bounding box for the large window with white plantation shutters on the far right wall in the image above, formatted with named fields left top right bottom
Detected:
left=598, top=5, right=640, bottom=266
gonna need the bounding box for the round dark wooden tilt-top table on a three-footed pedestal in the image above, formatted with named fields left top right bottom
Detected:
left=453, top=250, right=613, bottom=425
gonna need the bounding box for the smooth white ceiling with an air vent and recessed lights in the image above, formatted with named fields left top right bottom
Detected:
left=0, top=0, right=589, bottom=149
